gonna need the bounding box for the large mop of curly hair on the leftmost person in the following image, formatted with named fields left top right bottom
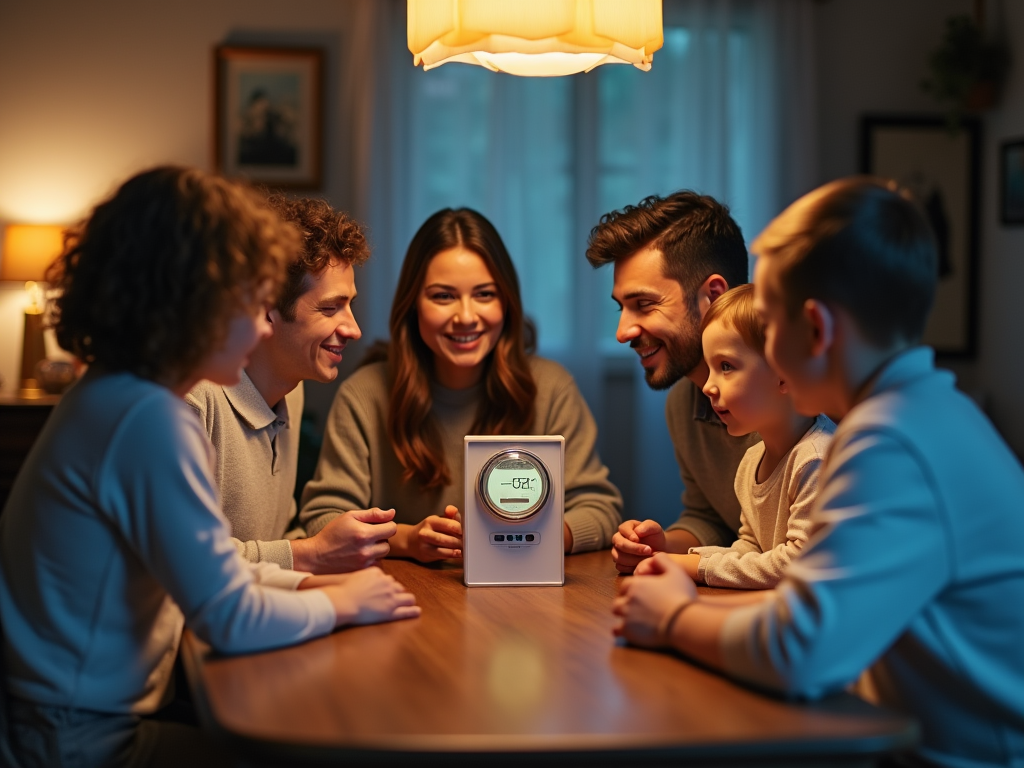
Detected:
left=47, top=166, right=299, bottom=386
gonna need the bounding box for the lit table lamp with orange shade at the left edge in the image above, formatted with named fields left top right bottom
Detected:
left=0, top=224, right=63, bottom=399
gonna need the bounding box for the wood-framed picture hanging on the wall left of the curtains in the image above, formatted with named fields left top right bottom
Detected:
left=213, top=46, right=324, bottom=189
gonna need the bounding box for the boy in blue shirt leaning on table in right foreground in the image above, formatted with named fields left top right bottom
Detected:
left=614, top=177, right=1024, bottom=766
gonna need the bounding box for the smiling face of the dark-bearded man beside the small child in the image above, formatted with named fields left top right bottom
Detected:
left=611, top=248, right=700, bottom=389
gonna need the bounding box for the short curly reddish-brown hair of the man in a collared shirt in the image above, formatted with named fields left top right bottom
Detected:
left=267, top=195, right=370, bottom=322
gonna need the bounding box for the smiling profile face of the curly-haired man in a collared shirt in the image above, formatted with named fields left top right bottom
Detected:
left=267, top=261, right=362, bottom=386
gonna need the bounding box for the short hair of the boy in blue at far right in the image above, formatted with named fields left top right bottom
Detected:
left=752, top=176, right=938, bottom=348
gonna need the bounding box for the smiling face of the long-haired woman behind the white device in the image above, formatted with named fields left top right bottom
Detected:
left=416, top=246, right=505, bottom=389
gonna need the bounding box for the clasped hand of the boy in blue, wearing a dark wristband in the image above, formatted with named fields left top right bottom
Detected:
left=611, top=553, right=697, bottom=648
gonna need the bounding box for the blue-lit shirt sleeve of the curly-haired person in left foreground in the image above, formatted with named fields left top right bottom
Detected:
left=98, top=400, right=335, bottom=652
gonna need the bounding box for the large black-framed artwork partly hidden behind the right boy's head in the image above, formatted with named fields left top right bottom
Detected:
left=860, top=115, right=981, bottom=357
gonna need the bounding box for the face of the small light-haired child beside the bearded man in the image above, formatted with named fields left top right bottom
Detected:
left=702, top=319, right=790, bottom=436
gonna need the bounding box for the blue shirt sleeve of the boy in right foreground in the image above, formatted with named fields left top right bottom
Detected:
left=721, top=428, right=950, bottom=698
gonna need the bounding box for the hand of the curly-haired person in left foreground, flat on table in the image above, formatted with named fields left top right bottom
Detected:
left=313, top=566, right=420, bottom=627
